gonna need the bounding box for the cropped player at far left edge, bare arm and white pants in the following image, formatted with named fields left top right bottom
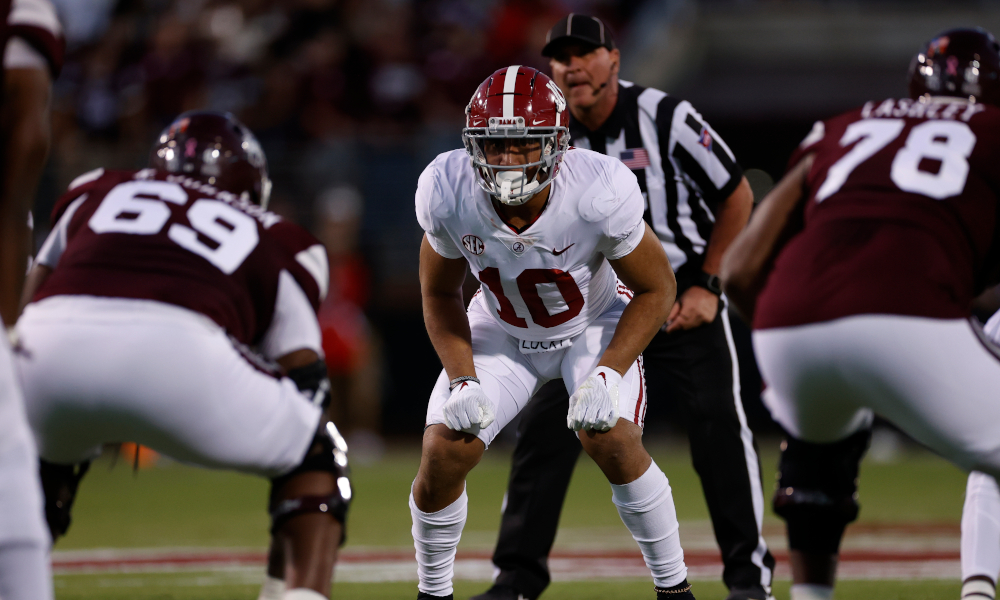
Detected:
left=0, top=0, right=63, bottom=600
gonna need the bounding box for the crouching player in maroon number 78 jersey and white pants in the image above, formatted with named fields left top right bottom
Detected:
left=722, top=29, right=1000, bottom=600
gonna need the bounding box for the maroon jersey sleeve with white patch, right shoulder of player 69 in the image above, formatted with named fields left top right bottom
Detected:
left=263, top=219, right=330, bottom=309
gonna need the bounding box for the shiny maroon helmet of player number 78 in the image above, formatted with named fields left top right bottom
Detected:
left=910, top=28, right=1000, bottom=106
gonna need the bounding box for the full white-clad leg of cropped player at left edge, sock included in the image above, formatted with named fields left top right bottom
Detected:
left=0, top=323, right=52, bottom=600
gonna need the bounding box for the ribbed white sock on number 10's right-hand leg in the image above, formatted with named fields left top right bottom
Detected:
left=611, top=462, right=687, bottom=588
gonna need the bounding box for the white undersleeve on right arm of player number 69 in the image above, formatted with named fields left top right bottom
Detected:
left=260, top=271, right=323, bottom=360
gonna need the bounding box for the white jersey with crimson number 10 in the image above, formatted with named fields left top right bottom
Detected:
left=416, top=148, right=645, bottom=341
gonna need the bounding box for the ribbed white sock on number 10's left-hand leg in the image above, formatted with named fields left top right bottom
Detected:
left=410, top=490, right=469, bottom=596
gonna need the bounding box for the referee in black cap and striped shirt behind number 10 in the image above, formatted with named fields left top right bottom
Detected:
left=473, top=14, right=774, bottom=600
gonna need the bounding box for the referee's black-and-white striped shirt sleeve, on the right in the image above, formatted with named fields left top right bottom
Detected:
left=657, top=101, right=743, bottom=203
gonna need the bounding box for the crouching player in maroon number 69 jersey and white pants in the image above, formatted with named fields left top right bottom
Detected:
left=16, top=112, right=351, bottom=600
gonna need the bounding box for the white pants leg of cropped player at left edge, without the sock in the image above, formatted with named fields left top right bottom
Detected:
left=0, top=335, right=49, bottom=547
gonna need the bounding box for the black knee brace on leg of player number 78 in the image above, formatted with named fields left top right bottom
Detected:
left=774, top=429, right=871, bottom=554
